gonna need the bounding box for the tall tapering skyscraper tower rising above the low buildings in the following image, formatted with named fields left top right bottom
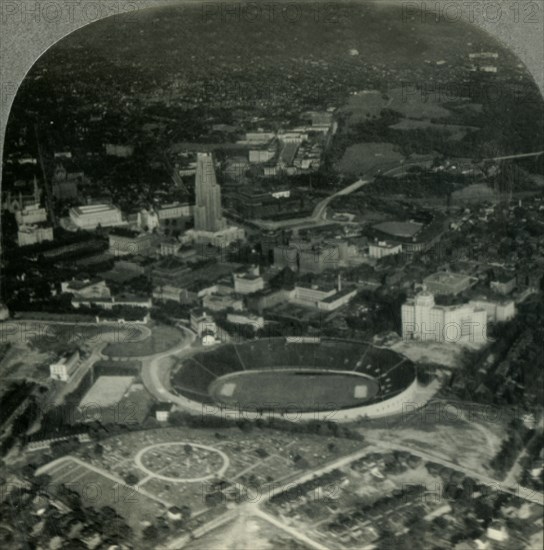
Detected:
left=195, top=153, right=227, bottom=233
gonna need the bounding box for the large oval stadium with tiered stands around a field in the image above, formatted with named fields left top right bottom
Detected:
left=171, top=337, right=418, bottom=421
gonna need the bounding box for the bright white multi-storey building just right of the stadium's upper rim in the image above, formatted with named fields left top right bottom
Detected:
left=401, top=292, right=487, bottom=344
